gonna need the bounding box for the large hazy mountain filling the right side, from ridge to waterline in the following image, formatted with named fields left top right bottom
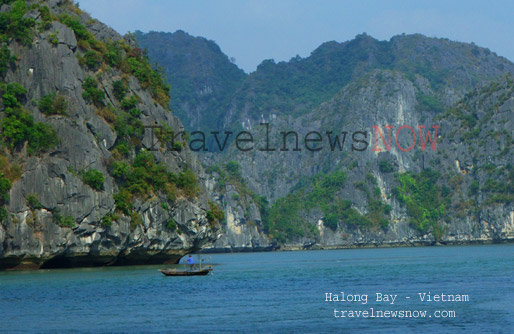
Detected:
left=134, top=33, right=514, bottom=248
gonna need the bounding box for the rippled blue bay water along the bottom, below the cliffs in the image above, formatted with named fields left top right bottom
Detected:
left=0, top=244, right=514, bottom=333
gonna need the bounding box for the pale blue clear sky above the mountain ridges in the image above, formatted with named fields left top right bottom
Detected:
left=79, top=0, right=514, bottom=73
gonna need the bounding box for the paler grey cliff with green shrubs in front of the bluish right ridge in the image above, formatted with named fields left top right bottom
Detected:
left=253, top=72, right=514, bottom=249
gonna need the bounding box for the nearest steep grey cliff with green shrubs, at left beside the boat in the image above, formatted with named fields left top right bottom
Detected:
left=0, top=0, right=221, bottom=269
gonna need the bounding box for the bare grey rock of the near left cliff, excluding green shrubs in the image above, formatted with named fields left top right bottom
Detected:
left=0, top=1, right=218, bottom=269
